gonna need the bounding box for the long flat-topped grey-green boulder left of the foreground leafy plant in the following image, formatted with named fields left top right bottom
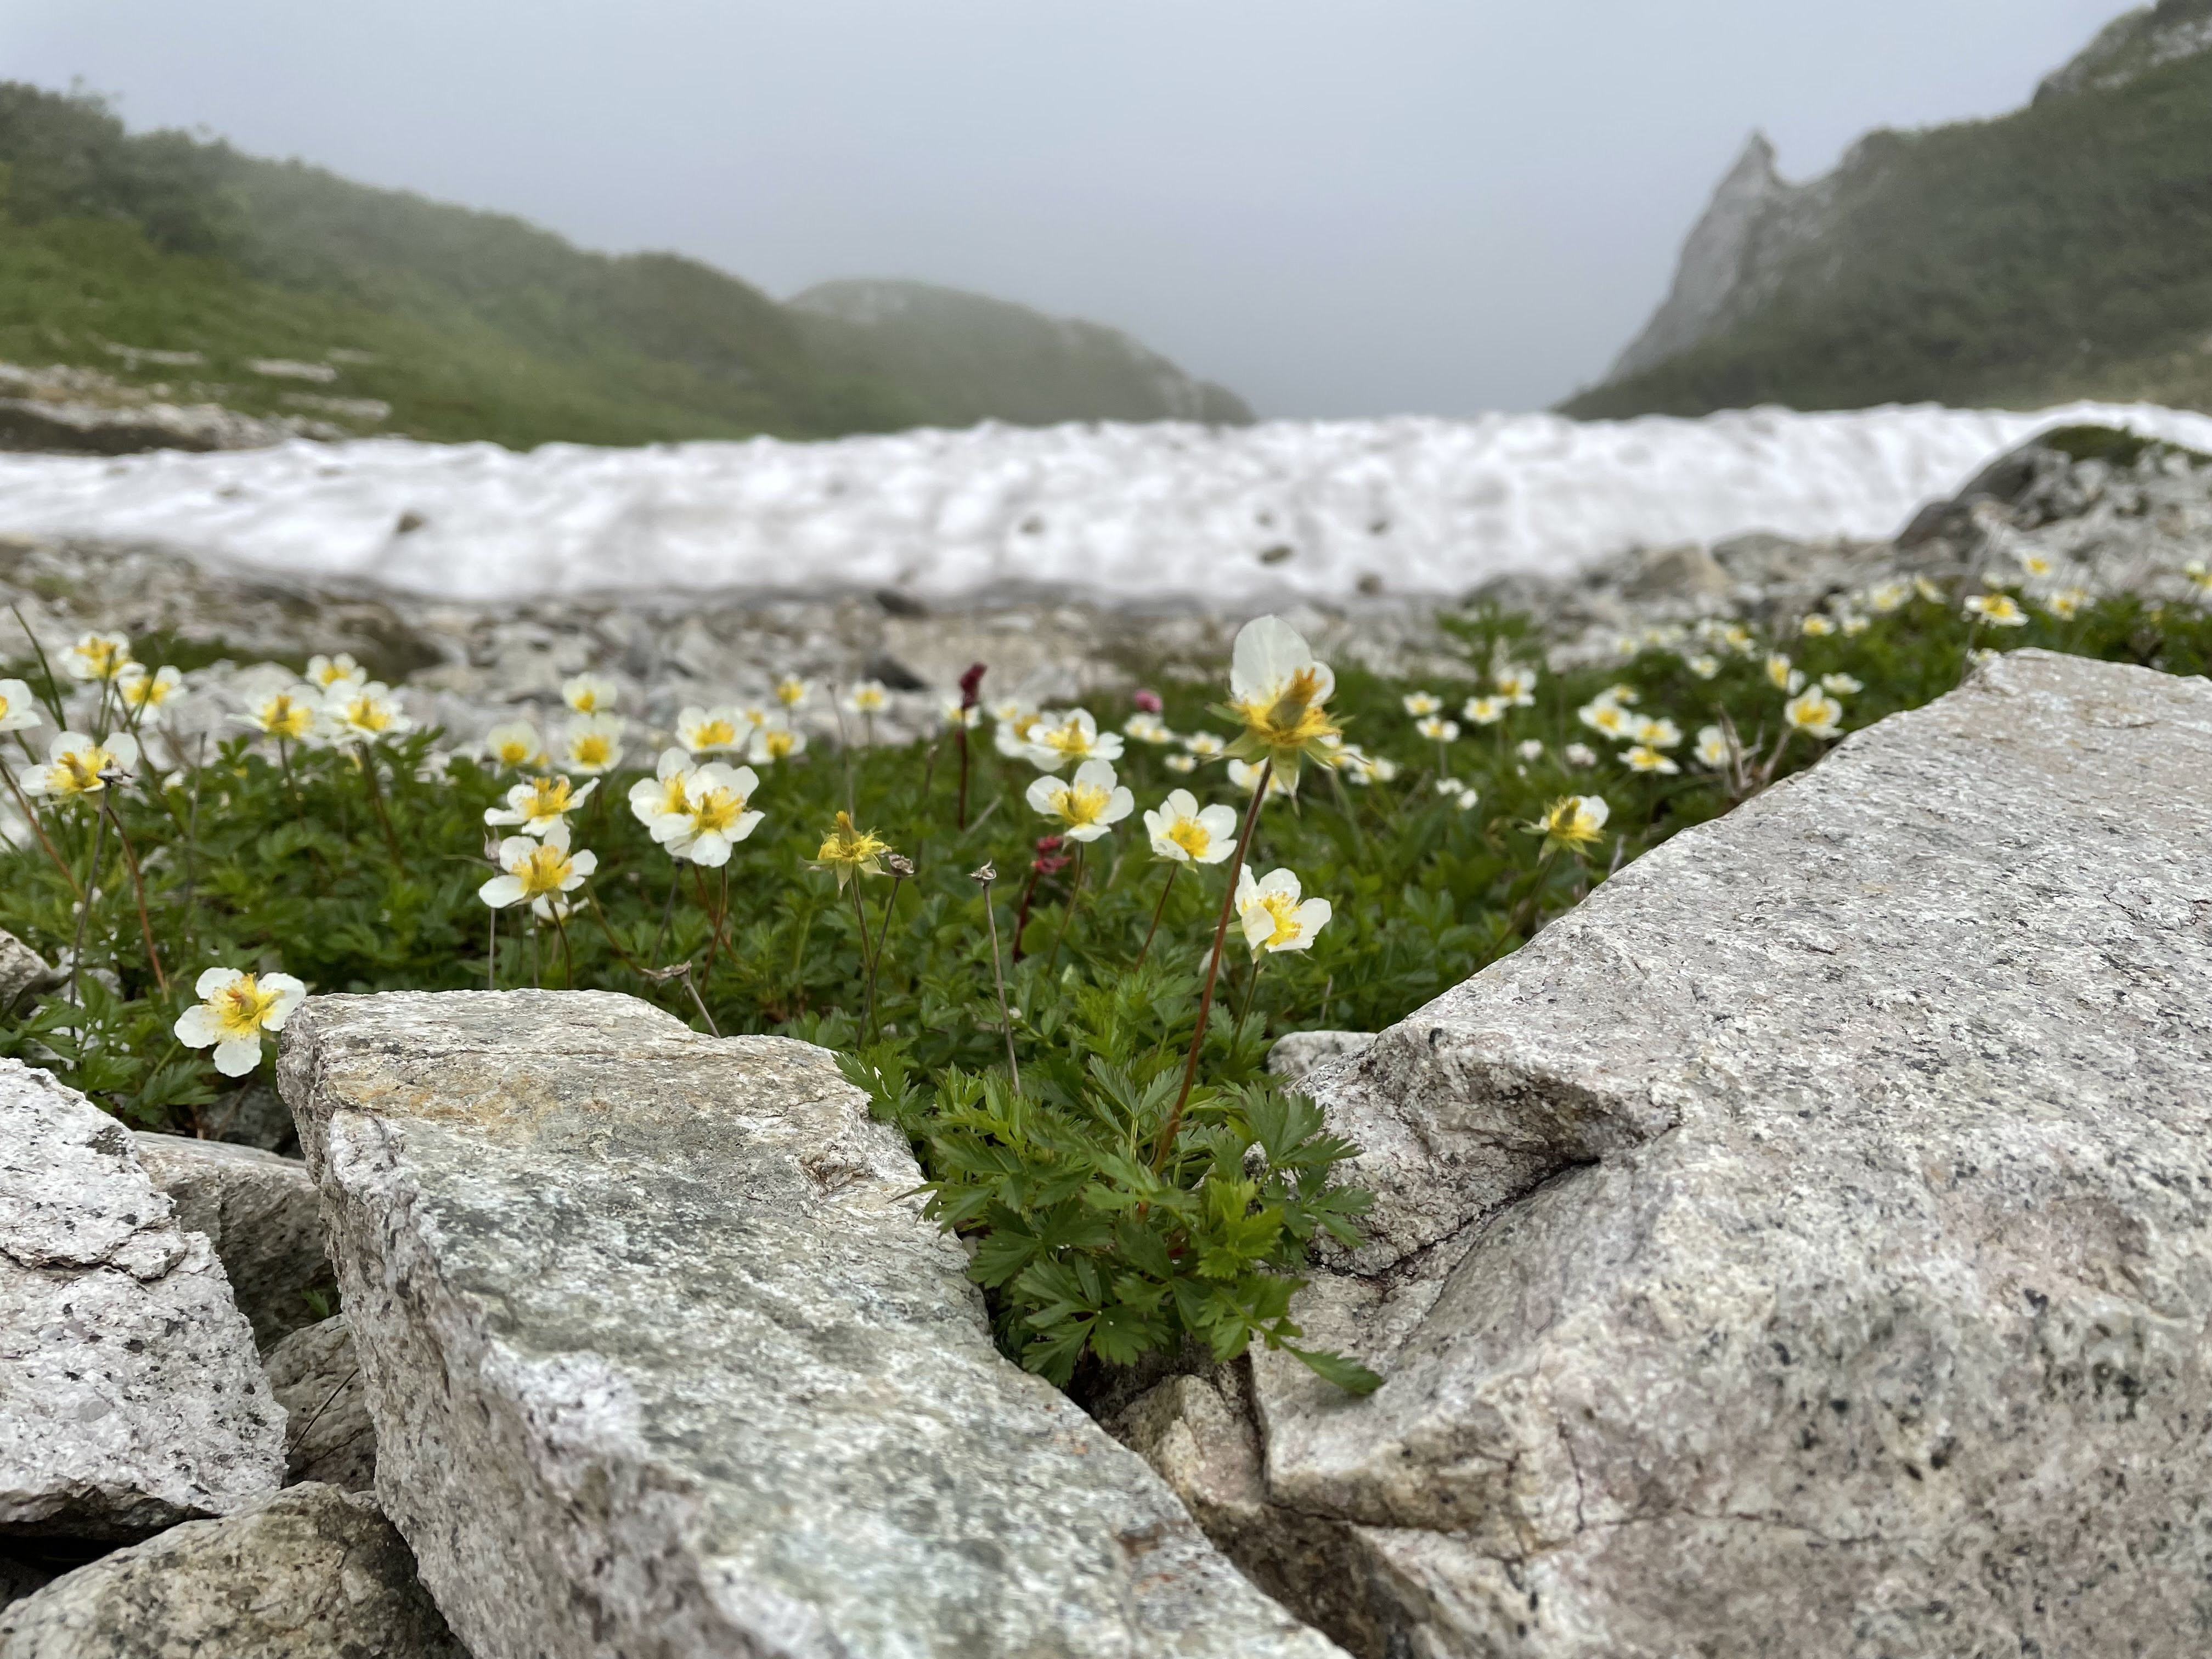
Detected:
left=279, top=991, right=1336, bottom=1659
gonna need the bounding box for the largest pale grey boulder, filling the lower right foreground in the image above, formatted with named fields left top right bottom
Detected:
left=1221, top=652, right=2212, bottom=1659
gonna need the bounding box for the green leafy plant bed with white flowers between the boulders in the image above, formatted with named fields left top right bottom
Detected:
left=0, top=584, right=2212, bottom=1387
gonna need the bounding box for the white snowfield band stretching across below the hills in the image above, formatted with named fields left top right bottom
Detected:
left=0, top=405, right=2212, bottom=608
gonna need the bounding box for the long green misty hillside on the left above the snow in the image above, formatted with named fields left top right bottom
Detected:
left=0, top=82, right=1248, bottom=447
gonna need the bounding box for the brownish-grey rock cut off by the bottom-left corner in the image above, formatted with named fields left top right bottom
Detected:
left=0, top=1487, right=469, bottom=1659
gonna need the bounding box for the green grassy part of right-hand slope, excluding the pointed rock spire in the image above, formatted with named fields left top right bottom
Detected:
left=1564, top=55, right=2212, bottom=416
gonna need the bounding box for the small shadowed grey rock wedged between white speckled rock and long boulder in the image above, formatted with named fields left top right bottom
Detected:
left=133, top=1132, right=338, bottom=1347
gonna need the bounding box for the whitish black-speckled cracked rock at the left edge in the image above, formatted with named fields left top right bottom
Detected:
left=0, top=1059, right=283, bottom=1539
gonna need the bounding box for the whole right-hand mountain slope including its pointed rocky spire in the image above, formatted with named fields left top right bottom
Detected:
left=1562, top=0, right=2212, bottom=418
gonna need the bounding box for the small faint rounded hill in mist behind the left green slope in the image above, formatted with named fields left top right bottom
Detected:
left=789, top=281, right=1252, bottom=425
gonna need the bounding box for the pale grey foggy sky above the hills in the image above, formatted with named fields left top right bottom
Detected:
left=0, top=0, right=2121, bottom=416
